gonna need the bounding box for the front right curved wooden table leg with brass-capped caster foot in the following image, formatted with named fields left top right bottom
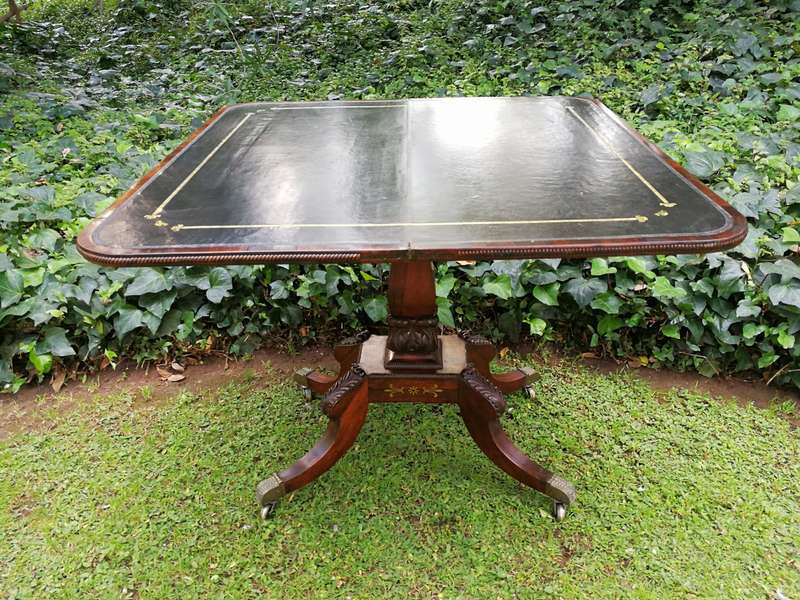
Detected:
left=459, top=366, right=575, bottom=520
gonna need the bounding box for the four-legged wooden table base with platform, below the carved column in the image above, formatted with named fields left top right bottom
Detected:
left=256, top=331, right=575, bottom=520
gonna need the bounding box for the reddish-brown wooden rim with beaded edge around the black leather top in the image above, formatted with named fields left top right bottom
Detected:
left=76, top=96, right=748, bottom=267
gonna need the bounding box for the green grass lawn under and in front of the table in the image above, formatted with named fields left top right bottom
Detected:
left=0, top=364, right=800, bottom=599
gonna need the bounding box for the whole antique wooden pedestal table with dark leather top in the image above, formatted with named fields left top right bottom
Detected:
left=78, top=97, right=746, bottom=519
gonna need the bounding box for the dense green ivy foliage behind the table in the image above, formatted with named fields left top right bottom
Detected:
left=0, top=0, right=800, bottom=390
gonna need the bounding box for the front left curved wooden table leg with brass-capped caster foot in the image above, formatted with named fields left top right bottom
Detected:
left=256, top=364, right=368, bottom=518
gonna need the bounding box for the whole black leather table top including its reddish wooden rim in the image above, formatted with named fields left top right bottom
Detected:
left=78, top=97, right=746, bottom=265
